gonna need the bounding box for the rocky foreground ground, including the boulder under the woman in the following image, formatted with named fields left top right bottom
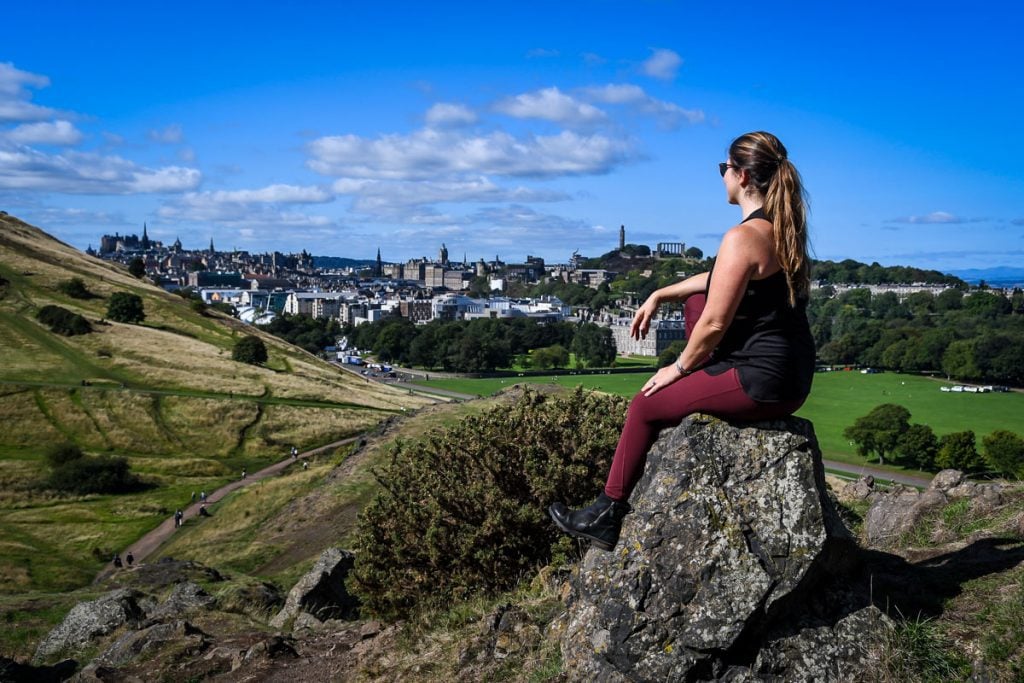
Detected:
left=8, top=420, right=1024, bottom=683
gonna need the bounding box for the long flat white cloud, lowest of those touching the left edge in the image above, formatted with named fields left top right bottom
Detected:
left=0, top=145, right=202, bottom=195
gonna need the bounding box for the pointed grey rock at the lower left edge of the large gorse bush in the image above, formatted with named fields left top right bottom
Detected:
left=270, top=548, right=358, bottom=629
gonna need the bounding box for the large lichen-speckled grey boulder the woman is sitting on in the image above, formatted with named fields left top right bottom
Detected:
left=562, top=416, right=886, bottom=681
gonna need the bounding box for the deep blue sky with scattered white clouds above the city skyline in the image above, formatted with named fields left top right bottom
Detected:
left=0, top=0, right=1024, bottom=270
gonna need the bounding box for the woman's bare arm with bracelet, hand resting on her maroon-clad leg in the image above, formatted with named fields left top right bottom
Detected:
left=638, top=225, right=759, bottom=396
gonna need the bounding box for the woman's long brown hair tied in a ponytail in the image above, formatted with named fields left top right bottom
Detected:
left=729, top=131, right=811, bottom=305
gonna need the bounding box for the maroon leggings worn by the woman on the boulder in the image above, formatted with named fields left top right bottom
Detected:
left=604, top=295, right=804, bottom=501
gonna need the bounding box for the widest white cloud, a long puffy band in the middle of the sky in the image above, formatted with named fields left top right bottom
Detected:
left=306, top=129, right=636, bottom=180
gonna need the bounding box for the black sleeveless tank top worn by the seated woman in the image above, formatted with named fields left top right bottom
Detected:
left=705, top=209, right=814, bottom=402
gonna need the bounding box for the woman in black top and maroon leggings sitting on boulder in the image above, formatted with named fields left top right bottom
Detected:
left=548, top=132, right=814, bottom=550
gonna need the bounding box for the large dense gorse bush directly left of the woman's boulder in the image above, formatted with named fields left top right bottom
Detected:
left=350, top=389, right=627, bottom=617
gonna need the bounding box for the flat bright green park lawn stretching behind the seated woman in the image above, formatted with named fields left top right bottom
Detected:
left=409, top=372, right=1024, bottom=464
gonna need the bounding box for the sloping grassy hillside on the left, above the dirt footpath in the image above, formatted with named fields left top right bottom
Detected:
left=0, top=215, right=425, bottom=592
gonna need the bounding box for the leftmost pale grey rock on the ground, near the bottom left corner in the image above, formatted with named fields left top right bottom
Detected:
left=36, top=588, right=145, bottom=660
